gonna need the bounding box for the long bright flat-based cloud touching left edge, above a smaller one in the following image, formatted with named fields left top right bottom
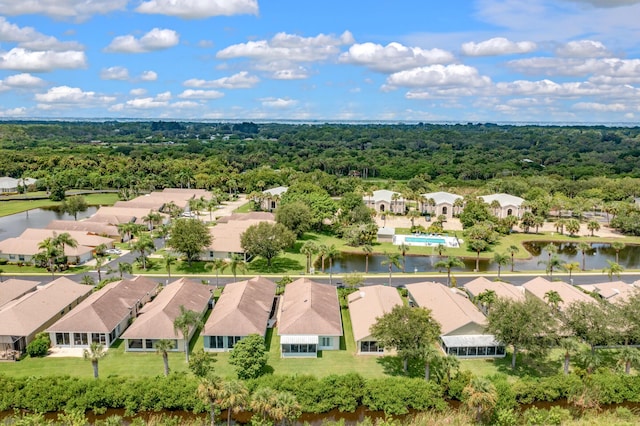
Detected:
left=0, top=47, right=87, bottom=72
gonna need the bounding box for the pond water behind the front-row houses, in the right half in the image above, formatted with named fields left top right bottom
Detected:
left=324, top=241, right=640, bottom=273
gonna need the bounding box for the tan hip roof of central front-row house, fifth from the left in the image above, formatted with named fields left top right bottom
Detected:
left=278, top=278, right=342, bottom=336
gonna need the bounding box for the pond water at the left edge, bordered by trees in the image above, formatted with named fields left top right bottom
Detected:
left=0, top=206, right=98, bottom=241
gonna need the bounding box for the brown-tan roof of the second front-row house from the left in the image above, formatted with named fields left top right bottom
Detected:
left=47, top=276, right=159, bottom=333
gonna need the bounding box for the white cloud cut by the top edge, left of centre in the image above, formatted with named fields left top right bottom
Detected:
left=136, top=0, right=258, bottom=19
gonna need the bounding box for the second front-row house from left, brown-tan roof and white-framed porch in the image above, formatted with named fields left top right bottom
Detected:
left=47, top=276, right=159, bottom=348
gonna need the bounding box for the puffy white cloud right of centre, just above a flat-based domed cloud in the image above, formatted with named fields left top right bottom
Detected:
left=339, top=43, right=454, bottom=73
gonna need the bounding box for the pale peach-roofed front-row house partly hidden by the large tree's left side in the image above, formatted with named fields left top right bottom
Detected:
left=347, top=285, right=403, bottom=355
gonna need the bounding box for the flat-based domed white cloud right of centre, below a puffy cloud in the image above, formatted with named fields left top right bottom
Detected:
left=383, top=64, right=491, bottom=90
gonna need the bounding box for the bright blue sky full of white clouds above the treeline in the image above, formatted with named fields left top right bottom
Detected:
left=0, top=0, right=640, bottom=123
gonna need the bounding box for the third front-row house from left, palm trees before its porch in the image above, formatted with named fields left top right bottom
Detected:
left=122, top=278, right=211, bottom=352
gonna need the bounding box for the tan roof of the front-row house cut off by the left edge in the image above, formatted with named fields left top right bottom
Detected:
left=0, top=277, right=92, bottom=336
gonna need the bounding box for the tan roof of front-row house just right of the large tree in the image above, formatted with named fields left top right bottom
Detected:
left=407, top=282, right=487, bottom=335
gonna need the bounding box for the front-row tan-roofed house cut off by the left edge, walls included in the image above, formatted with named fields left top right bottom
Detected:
left=0, top=277, right=93, bottom=358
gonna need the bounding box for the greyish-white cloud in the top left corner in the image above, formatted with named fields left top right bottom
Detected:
left=0, top=0, right=128, bottom=21
